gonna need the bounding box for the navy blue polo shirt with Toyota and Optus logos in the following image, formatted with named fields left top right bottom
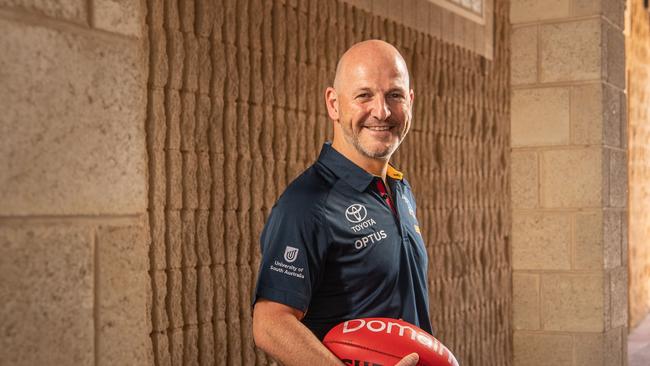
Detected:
left=254, top=143, right=431, bottom=339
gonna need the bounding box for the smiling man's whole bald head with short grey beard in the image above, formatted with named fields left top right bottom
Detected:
left=326, top=41, right=413, bottom=161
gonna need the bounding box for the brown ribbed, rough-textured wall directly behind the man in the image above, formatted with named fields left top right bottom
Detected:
left=147, top=0, right=512, bottom=365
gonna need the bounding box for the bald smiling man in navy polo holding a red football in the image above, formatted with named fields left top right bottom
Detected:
left=253, top=40, right=431, bottom=366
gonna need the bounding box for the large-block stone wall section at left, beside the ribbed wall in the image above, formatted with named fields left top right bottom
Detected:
left=0, top=0, right=151, bottom=365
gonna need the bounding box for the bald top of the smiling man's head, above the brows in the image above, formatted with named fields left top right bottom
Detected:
left=334, top=39, right=410, bottom=90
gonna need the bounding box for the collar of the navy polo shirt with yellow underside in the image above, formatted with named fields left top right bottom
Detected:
left=318, top=142, right=404, bottom=192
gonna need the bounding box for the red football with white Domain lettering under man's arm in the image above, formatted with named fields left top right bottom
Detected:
left=323, top=318, right=458, bottom=366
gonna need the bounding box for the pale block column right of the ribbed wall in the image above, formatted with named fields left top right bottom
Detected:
left=510, top=0, right=627, bottom=366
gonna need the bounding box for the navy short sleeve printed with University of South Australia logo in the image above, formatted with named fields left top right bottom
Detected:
left=253, top=202, right=328, bottom=312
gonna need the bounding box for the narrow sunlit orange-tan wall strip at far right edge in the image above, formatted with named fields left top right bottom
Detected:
left=626, top=1, right=650, bottom=327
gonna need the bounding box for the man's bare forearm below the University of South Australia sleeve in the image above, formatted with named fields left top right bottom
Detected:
left=253, top=313, right=343, bottom=366
